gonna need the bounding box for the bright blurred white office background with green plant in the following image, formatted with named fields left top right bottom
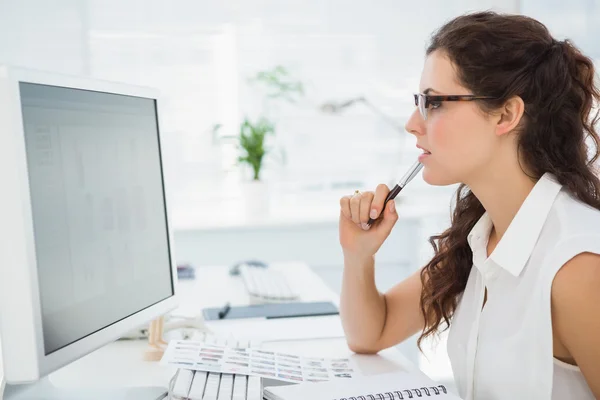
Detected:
left=0, top=0, right=600, bottom=388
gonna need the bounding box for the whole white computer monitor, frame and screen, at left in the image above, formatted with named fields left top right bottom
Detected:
left=0, top=67, right=177, bottom=398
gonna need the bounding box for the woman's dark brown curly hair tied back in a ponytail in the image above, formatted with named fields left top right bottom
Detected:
left=417, top=12, right=600, bottom=348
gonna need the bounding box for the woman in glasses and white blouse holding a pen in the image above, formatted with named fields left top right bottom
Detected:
left=340, top=12, right=600, bottom=399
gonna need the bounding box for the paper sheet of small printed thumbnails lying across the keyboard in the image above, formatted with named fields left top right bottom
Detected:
left=160, top=340, right=358, bottom=383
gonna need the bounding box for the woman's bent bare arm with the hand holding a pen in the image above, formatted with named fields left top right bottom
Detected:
left=340, top=184, right=424, bottom=353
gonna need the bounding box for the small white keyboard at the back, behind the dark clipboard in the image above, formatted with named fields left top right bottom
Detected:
left=239, top=265, right=299, bottom=303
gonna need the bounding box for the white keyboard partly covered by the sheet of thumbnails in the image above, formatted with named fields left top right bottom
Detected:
left=168, top=332, right=263, bottom=400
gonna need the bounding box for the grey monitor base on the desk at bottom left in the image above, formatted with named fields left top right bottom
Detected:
left=0, top=377, right=167, bottom=400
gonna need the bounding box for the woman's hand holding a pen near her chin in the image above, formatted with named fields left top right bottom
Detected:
left=340, top=184, right=398, bottom=259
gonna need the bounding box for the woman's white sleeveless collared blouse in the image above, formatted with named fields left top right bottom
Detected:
left=448, top=174, right=600, bottom=400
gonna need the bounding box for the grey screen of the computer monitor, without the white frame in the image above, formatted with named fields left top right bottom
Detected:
left=19, top=82, right=174, bottom=355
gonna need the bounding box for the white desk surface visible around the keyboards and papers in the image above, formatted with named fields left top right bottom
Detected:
left=50, top=263, right=417, bottom=388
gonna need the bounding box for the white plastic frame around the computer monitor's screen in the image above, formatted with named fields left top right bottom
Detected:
left=0, top=66, right=178, bottom=383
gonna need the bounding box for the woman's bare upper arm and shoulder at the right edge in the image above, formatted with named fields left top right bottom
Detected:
left=552, top=253, right=600, bottom=399
